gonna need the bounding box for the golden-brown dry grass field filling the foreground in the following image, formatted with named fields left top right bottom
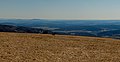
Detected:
left=0, top=33, right=120, bottom=62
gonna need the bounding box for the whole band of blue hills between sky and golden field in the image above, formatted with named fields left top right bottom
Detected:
left=0, top=19, right=120, bottom=38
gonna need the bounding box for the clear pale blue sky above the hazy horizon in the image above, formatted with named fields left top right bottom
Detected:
left=0, top=0, right=120, bottom=20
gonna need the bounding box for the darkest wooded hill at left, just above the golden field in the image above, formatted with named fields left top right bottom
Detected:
left=0, top=25, right=52, bottom=34
